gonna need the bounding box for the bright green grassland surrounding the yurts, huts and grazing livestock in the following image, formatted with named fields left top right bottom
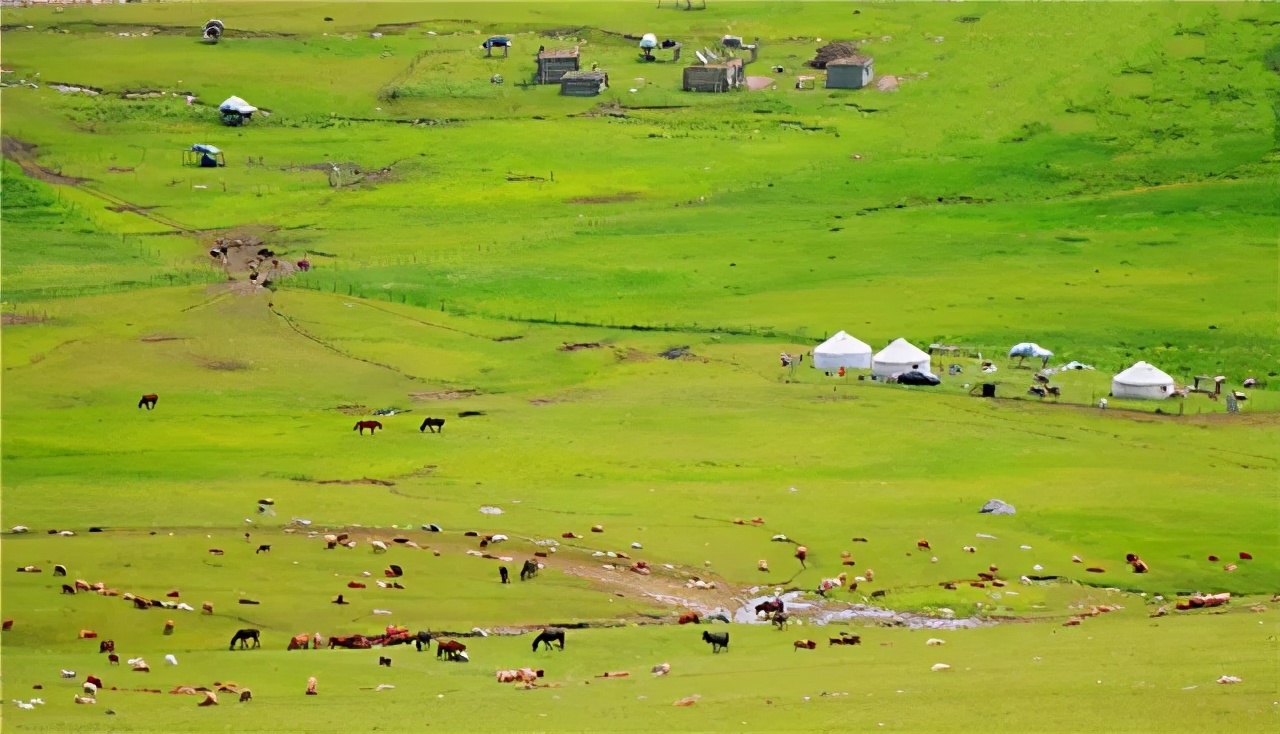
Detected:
left=0, top=1, right=1280, bottom=731
